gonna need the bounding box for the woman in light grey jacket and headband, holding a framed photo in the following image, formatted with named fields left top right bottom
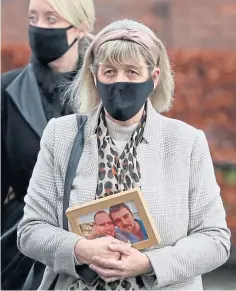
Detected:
left=18, top=20, right=230, bottom=290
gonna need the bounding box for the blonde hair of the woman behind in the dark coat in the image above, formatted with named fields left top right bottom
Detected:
left=49, top=0, right=95, bottom=33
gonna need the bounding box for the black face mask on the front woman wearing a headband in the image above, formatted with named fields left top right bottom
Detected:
left=97, top=78, right=154, bottom=121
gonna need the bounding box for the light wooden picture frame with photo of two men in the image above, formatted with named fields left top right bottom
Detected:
left=66, top=188, right=160, bottom=250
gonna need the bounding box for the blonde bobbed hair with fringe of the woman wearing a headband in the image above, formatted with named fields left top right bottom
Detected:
left=68, top=19, right=174, bottom=114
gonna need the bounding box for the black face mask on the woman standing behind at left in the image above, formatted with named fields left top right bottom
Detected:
left=29, top=25, right=77, bottom=64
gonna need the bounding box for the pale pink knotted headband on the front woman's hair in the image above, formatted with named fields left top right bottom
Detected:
left=93, top=29, right=159, bottom=64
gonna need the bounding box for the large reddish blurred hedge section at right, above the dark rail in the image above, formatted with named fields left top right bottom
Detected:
left=167, top=51, right=236, bottom=164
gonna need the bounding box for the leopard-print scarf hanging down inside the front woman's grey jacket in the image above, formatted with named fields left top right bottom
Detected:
left=69, top=109, right=146, bottom=290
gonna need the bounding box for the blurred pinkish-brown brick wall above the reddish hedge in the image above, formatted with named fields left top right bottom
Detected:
left=2, top=0, right=236, bottom=49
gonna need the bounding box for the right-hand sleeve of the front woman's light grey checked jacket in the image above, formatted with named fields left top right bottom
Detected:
left=143, top=130, right=230, bottom=289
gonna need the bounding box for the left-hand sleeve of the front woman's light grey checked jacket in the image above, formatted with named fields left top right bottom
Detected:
left=17, top=119, right=82, bottom=278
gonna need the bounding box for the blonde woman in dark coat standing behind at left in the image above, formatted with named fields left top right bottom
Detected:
left=1, top=0, right=95, bottom=289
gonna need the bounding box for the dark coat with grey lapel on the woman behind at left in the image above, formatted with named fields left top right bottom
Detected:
left=1, top=63, right=74, bottom=290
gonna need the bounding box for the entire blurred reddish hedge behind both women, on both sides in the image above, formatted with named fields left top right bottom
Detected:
left=1, top=45, right=236, bottom=246
